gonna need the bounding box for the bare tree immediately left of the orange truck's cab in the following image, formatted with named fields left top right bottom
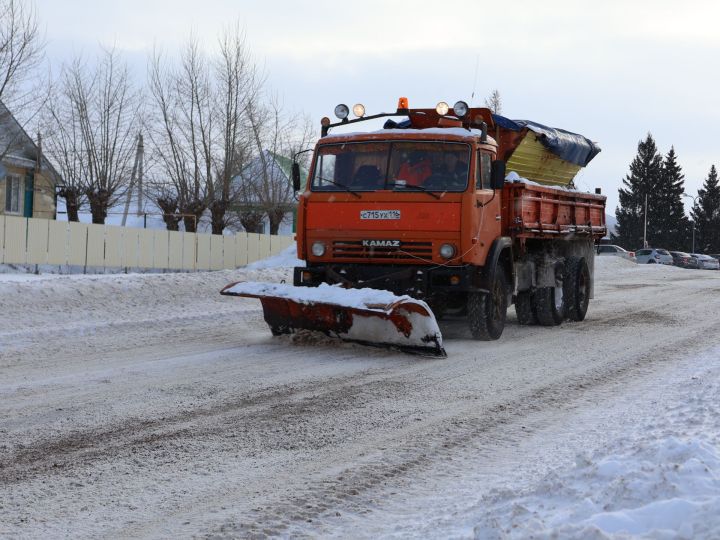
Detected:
left=242, top=97, right=312, bottom=234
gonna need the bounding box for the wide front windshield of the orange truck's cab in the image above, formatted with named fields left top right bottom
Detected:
left=311, top=142, right=470, bottom=191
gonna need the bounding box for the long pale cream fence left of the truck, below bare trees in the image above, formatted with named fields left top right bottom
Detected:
left=0, top=216, right=293, bottom=270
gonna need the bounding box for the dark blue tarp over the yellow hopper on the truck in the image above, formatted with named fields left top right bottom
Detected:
left=493, top=114, right=600, bottom=167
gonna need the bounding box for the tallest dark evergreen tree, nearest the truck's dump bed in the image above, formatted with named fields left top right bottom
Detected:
left=613, top=133, right=663, bottom=250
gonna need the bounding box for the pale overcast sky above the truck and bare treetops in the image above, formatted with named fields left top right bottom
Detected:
left=36, top=0, right=720, bottom=213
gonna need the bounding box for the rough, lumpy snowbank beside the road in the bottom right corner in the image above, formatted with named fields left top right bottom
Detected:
left=474, top=346, right=720, bottom=538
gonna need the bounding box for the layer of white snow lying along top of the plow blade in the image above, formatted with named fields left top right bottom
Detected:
left=225, top=281, right=416, bottom=311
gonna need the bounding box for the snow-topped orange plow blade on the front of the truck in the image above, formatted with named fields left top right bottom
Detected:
left=220, top=281, right=447, bottom=358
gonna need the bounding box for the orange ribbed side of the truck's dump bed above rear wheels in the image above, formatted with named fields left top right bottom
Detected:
left=502, top=182, right=607, bottom=239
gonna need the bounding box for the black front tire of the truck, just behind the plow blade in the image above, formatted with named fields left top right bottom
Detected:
left=467, top=268, right=507, bottom=341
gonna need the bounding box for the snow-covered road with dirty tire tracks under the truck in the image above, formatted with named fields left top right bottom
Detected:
left=0, top=258, right=720, bottom=538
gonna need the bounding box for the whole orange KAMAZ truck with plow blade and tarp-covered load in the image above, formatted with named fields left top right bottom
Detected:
left=226, top=98, right=606, bottom=354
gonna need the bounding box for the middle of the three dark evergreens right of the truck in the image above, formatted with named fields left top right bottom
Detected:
left=648, top=147, right=692, bottom=251
